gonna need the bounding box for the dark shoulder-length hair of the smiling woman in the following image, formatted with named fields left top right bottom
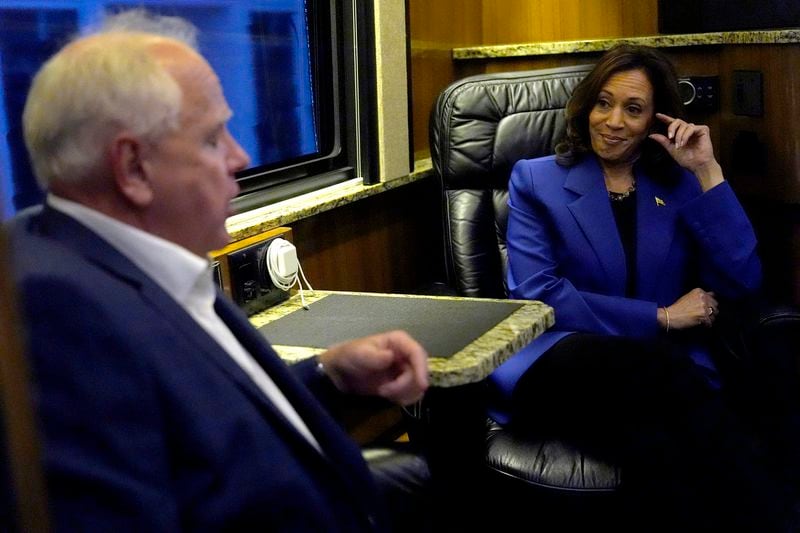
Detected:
left=556, top=44, right=684, bottom=174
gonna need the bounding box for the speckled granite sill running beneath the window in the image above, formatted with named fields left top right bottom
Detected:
left=226, top=158, right=432, bottom=241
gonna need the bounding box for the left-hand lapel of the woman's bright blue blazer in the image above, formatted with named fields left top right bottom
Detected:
left=564, top=157, right=626, bottom=294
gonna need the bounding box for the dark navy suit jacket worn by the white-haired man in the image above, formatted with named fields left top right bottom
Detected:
left=11, top=207, right=385, bottom=533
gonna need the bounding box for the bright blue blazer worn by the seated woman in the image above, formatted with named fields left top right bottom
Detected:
left=489, top=156, right=761, bottom=422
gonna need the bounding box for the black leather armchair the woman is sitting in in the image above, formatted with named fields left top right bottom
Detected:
left=430, top=66, right=800, bottom=531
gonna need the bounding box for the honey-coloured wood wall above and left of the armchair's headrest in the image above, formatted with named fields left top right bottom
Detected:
left=408, top=0, right=658, bottom=159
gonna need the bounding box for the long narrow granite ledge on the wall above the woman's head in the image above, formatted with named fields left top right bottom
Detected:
left=453, top=28, right=800, bottom=59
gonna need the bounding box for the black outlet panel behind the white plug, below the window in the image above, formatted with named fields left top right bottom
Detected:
left=228, top=237, right=289, bottom=315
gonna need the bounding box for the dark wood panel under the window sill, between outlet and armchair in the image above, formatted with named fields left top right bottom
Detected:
left=292, top=179, right=444, bottom=293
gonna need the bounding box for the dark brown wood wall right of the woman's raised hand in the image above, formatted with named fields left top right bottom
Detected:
left=715, top=45, right=800, bottom=305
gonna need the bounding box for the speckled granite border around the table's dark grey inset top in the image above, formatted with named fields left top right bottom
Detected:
left=250, top=291, right=555, bottom=387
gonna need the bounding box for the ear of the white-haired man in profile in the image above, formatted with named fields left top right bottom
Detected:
left=109, top=133, right=154, bottom=207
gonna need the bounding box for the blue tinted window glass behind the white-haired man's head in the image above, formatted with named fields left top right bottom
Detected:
left=0, top=0, right=320, bottom=217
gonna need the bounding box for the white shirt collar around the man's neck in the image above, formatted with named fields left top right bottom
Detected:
left=47, top=193, right=214, bottom=304
